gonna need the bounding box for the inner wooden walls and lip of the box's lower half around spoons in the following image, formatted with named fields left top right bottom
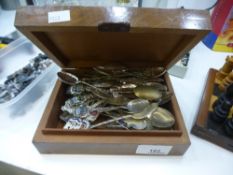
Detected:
left=42, top=69, right=182, bottom=136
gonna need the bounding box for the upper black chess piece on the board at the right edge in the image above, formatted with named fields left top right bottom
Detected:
left=211, top=83, right=233, bottom=123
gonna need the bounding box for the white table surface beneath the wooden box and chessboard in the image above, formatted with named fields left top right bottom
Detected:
left=0, top=8, right=233, bottom=175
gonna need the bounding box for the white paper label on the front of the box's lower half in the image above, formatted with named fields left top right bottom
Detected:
left=136, top=145, right=172, bottom=155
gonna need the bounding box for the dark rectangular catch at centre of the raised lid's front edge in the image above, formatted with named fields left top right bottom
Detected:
left=98, top=22, right=130, bottom=32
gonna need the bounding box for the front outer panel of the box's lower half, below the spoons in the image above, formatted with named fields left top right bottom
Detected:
left=34, top=143, right=189, bottom=156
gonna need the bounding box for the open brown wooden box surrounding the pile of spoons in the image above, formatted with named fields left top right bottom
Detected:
left=15, top=6, right=211, bottom=155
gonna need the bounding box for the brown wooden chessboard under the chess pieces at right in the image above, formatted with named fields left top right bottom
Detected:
left=191, top=69, right=233, bottom=151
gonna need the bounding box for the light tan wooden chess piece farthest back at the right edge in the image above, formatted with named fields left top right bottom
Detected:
left=216, top=56, right=233, bottom=81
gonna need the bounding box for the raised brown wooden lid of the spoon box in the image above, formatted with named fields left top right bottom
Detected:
left=15, top=6, right=211, bottom=68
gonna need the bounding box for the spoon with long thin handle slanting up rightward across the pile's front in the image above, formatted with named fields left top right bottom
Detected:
left=90, top=103, right=158, bottom=128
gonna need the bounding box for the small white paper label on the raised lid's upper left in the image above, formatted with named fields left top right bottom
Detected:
left=48, top=10, right=70, bottom=23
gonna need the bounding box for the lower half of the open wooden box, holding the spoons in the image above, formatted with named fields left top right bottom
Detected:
left=33, top=70, right=190, bottom=155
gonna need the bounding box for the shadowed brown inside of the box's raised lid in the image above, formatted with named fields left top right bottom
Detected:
left=32, top=31, right=195, bottom=67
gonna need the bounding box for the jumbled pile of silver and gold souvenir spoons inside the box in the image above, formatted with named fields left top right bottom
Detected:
left=58, top=66, right=175, bottom=130
